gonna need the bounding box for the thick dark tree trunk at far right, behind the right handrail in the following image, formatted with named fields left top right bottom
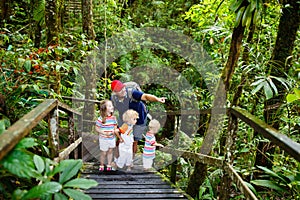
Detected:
left=255, top=0, right=300, bottom=168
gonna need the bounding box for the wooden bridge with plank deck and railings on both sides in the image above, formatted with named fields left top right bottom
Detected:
left=0, top=99, right=300, bottom=199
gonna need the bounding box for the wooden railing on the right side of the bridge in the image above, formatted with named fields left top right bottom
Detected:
left=160, top=107, right=300, bottom=200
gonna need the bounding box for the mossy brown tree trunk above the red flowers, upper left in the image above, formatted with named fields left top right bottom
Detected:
left=45, top=0, right=59, bottom=46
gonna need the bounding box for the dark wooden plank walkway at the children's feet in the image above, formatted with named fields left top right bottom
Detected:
left=81, top=163, right=191, bottom=200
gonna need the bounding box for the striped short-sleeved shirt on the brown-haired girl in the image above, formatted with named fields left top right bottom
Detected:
left=96, top=115, right=117, bottom=140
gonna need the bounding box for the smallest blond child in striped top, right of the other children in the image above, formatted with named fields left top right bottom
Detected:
left=143, top=119, right=164, bottom=171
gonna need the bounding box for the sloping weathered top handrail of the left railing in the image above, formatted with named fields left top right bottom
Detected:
left=0, top=99, right=58, bottom=160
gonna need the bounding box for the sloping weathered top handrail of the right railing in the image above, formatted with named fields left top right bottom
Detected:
left=230, top=107, right=300, bottom=161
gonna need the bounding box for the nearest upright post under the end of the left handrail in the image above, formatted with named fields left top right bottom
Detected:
left=48, top=106, right=59, bottom=159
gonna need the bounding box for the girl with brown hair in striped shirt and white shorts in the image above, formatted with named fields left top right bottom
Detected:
left=95, top=99, right=122, bottom=172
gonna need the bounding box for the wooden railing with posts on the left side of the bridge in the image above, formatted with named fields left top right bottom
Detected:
left=0, top=99, right=82, bottom=161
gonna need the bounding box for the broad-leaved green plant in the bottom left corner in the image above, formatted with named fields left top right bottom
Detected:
left=0, top=138, right=98, bottom=199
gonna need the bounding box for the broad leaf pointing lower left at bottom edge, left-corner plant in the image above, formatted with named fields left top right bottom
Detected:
left=24, top=182, right=62, bottom=199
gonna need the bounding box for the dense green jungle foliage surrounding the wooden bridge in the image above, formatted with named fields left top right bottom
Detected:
left=0, top=0, right=300, bottom=199
